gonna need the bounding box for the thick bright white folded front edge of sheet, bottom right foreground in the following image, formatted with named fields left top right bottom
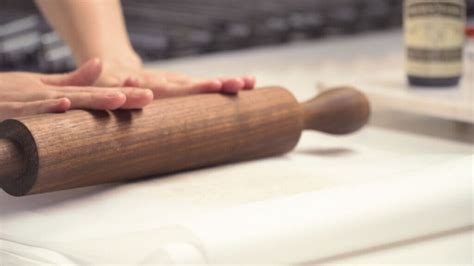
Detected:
left=154, top=157, right=474, bottom=264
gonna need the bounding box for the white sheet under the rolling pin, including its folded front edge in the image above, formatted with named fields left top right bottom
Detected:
left=0, top=132, right=472, bottom=263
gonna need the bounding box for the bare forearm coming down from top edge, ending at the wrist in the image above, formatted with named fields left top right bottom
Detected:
left=36, top=0, right=141, bottom=65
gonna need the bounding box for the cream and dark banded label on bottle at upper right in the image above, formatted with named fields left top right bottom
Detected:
left=404, top=0, right=466, bottom=78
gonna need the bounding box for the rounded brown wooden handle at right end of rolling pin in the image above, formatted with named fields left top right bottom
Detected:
left=301, top=87, right=370, bottom=135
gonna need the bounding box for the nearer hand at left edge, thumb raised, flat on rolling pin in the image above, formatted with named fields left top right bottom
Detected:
left=0, top=59, right=153, bottom=121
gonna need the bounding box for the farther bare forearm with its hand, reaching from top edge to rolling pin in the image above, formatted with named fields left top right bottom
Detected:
left=36, top=0, right=255, bottom=94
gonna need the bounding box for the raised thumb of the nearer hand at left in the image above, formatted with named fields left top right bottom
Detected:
left=41, top=58, right=102, bottom=86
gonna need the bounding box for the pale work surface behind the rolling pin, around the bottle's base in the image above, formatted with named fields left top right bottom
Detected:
left=157, top=31, right=474, bottom=123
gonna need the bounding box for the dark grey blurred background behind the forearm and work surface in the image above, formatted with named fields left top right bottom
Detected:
left=0, top=0, right=474, bottom=73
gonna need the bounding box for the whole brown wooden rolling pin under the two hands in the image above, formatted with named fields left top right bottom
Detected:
left=0, top=87, right=370, bottom=196
